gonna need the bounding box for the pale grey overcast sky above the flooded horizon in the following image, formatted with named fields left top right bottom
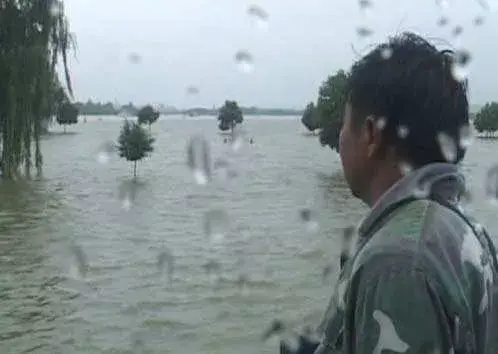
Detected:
left=65, top=0, right=498, bottom=107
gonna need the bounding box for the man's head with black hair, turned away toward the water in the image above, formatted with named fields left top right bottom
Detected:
left=339, top=33, right=469, bottom=204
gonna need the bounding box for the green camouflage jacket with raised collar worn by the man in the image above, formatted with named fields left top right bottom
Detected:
left=315, top=164, right=498, bottom=354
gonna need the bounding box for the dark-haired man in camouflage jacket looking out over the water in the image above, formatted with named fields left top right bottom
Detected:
left=290, top=33, right=498, bottom=354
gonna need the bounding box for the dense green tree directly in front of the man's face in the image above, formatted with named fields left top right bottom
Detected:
left=316, top=70, right=349, bottom=150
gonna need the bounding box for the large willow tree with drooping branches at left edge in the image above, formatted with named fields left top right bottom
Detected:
left=0, top=0, right=73, bottom=178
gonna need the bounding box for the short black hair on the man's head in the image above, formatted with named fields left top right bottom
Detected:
left=348, top=32, right=469, bottom=167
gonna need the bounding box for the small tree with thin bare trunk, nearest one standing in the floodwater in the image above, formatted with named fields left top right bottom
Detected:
left=118, top=120, right=154, bottom=178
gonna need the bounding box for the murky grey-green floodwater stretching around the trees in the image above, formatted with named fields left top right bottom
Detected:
left=0, top=117, right=498, bottom=354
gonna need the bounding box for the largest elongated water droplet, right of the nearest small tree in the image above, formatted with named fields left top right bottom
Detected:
left=187, top=135, right=211, bottom=185
